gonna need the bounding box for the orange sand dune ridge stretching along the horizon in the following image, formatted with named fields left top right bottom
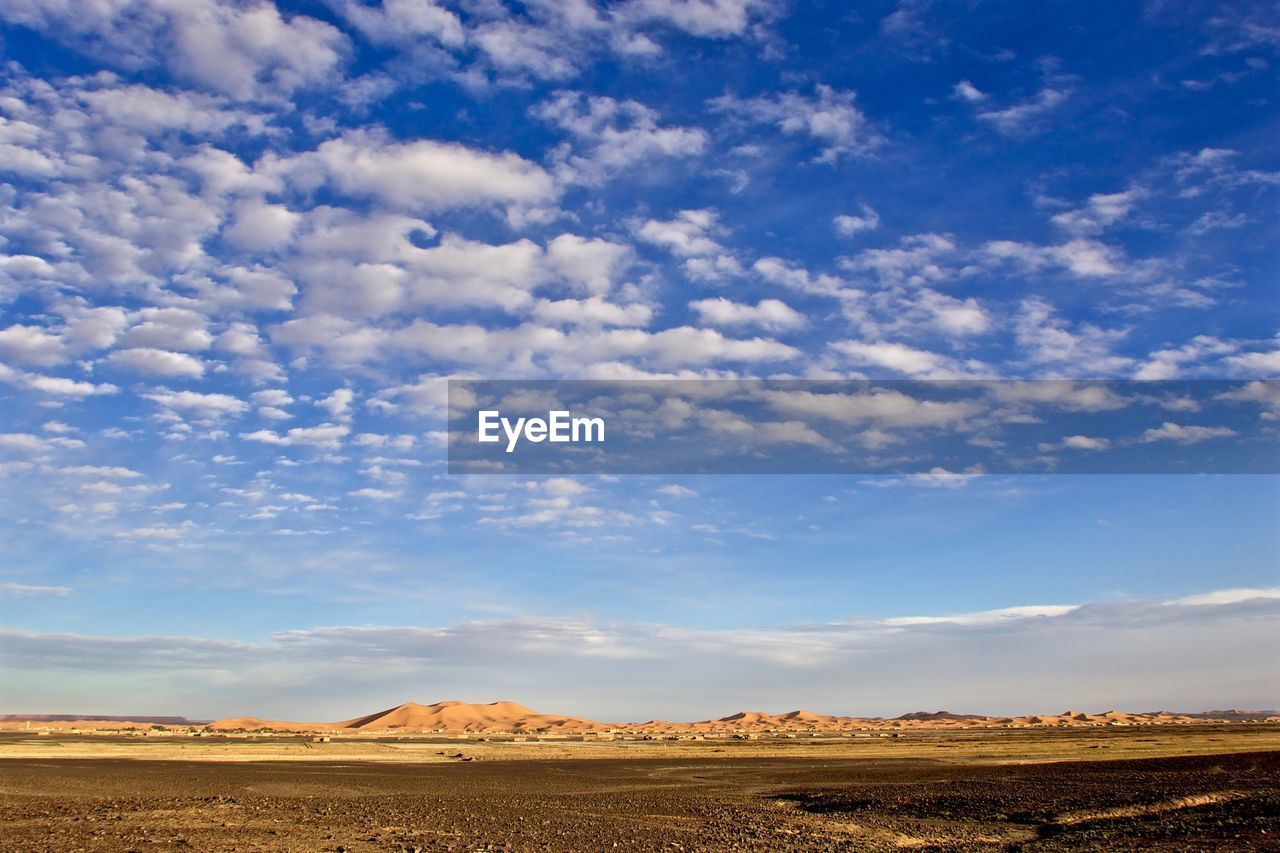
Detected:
left=0, top=701, right=1280, bottom=738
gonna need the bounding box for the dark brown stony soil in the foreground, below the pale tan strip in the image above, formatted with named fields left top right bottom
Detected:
left=0, top=730, right=1280, bottom=850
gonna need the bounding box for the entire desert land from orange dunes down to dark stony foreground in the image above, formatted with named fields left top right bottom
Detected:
left=0, top=702, right=1280, bottom=852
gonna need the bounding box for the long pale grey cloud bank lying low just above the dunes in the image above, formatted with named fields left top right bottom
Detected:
left=0, top=589, right=1280, bottom=721
